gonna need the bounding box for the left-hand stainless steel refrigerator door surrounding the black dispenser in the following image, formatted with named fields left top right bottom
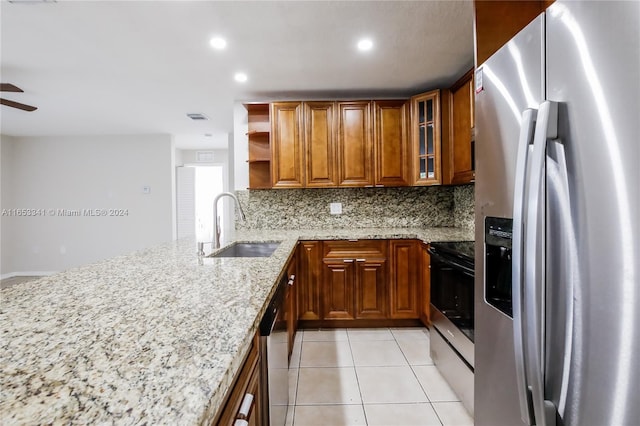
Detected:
left=474, top=17, right=544, bottom=426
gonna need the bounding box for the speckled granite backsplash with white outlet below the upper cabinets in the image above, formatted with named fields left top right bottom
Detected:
left=236, top=185, right=473, bottom=230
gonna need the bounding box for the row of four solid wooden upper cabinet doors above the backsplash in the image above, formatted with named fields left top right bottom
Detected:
left=260, top=100, right=411, bottom=188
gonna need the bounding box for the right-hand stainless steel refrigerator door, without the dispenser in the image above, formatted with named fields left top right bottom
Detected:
left=544, top=0, right=640, bottom=426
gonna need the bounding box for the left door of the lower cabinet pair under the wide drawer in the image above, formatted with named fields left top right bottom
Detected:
left=322, top=259, right=355, bottom=319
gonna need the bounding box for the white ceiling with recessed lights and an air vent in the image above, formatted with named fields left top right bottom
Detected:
left=0, top=0, right=473, bottom=148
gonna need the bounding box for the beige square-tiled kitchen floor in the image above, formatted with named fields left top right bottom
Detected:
left=287, top=328, right=473, bottom=426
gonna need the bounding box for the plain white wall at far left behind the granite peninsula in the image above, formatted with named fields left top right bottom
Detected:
left=0, top=135, right=175, bottom=276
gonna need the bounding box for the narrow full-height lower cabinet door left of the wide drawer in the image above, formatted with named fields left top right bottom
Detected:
left=295, top=241, right=322, bottom=320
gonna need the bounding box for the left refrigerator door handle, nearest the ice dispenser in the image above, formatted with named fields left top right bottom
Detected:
left=511, top=109, right=537, bottom=425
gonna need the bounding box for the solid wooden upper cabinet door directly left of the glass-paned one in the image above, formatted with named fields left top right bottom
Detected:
left=373, top=100, right=409, bottom=186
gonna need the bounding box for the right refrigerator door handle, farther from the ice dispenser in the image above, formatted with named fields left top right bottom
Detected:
left=523, top=101, right=558, bottom=426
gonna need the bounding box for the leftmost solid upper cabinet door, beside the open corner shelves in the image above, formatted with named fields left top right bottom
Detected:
left=271, top=102, right=303, bottom=188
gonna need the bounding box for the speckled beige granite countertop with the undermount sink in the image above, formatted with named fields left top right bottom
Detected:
left=0, top=228, right=474, bottom=425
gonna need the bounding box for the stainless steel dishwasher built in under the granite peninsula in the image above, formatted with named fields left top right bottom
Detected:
left=260, top=275, right=289, bottom=426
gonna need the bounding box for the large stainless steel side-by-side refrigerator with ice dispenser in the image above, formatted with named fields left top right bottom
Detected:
left=474, top=1, right=640, bottom=426
